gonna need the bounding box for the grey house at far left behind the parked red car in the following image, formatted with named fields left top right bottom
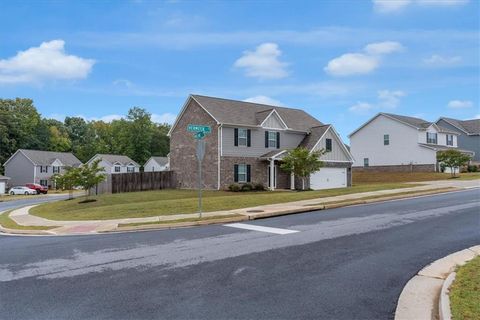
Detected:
left=4, top=149, right=82, bottom=188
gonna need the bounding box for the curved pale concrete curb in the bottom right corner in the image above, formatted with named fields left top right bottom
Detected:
left=395, top=245, right=480, bottom=320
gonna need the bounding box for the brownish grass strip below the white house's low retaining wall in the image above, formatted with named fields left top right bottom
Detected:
left=352, top=172, right=480, bottom=184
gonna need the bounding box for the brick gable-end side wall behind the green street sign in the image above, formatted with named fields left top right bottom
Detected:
left=170, top=99, right=218, bottom=189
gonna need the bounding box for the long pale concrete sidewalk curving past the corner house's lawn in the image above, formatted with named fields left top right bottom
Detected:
left=1, top=180, right=480, bottom=235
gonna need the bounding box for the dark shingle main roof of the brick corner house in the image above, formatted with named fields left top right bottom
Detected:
left=192, top=95, right=322, bottom=132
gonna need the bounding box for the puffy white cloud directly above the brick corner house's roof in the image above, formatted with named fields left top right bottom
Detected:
left=234, top=43, right=288, bottom=79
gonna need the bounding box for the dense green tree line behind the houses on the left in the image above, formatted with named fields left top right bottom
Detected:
left=0, top=98, right=170, bottom=173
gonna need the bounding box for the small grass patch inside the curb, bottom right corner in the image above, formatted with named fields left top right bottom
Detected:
left=449, top=257, right=480, bottom=320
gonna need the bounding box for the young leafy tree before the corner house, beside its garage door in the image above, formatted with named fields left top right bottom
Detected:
left=280, top=147, right=326, bottom=190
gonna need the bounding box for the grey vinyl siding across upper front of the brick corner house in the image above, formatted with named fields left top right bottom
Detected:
left=222, top=127, right=305, bottom=157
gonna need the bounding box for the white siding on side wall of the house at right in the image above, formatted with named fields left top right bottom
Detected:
left=350, top=115, right=436, bottom=167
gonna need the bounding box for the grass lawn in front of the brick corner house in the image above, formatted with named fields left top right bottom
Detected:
left=30, top=183, right=412, bottom=220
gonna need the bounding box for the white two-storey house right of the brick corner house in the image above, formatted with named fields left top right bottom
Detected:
left=349, top=113, right=474, bottom=171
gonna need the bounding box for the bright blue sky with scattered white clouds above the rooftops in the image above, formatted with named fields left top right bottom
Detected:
left=0, top=0, right=480, bottom=137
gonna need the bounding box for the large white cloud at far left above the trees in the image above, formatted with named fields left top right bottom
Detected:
left=0, top=40, right=95, bottom=84
